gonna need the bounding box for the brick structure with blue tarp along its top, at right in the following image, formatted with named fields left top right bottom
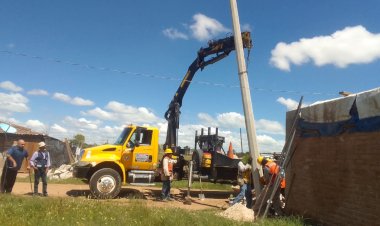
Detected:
left=286, top=88, right=380, bottom=225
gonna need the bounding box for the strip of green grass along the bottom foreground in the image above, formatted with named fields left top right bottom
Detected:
left=0, top=195, right=302, bottom=226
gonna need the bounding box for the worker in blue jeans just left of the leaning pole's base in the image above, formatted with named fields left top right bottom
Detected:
left=232, top=157, right=252, bottom=208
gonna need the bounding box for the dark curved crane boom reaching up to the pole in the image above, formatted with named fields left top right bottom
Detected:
left=164, top=32, right=252, bottom=151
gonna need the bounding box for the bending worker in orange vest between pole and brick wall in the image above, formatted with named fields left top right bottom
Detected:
left=253, top=156, right=285, bottom=215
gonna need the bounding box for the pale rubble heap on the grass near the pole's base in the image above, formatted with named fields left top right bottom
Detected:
left=217, top=203, right=255, bottom=221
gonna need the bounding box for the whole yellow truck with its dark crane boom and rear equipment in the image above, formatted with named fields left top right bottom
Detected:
left=73, top=32, right=252, bottom=198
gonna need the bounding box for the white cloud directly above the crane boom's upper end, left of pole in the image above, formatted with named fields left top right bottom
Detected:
left=190, top=13, right=230, bottom=41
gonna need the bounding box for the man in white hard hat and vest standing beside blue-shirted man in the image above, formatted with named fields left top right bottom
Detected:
left=30, top=141, right=50, bottom=196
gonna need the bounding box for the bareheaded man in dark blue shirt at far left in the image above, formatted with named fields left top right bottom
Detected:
left=0, top=139, right=29, bottom=193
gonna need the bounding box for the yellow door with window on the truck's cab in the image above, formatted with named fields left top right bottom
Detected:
left=124, top=128, right=153, bottom=170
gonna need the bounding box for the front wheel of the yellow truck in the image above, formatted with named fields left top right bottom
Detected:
left=90, top=168, right=121, bottom=199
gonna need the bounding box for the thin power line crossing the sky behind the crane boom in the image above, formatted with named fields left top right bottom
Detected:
left=0, top=50, right=337, bottom=96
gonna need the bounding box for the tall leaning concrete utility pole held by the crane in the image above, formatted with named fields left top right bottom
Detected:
left=230, top=0, right=261, bottom=194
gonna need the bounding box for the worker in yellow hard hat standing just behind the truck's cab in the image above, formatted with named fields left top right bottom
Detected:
left=161, top=148, right=173, bottom=201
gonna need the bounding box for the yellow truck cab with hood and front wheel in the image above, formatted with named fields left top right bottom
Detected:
left=73, top=125, right=159, bottom=198
